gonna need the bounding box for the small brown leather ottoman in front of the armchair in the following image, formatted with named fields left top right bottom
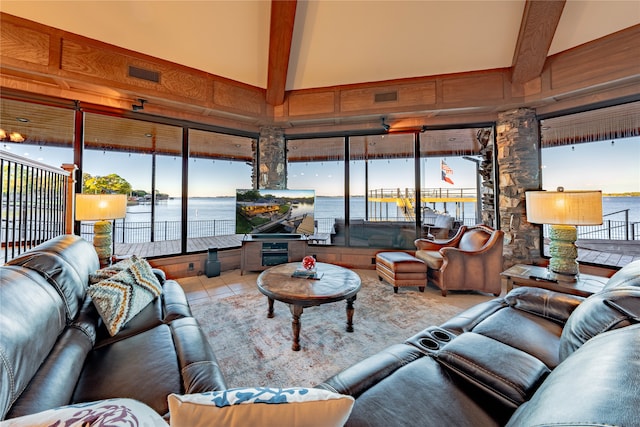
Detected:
left=376, top=252, right=427, bottom=293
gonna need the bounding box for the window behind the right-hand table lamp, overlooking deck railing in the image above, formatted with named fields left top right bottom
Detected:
left=540, top=102, right=640, bottom=266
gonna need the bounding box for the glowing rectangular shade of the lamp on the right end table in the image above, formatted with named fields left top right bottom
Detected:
left=525, top=191, right=602, bottom=225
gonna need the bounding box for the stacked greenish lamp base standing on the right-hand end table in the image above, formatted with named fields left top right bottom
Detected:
left=549, top=225, right=579, bottom=281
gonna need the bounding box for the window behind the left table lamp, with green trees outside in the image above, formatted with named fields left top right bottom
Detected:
left=82, top=113, right=182, bottom=256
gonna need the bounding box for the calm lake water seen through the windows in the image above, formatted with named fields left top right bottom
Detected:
left=126, top=196, right=640, bottom=222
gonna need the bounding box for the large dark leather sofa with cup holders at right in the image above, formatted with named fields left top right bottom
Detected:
left=318, top=261, right=640, bottom=427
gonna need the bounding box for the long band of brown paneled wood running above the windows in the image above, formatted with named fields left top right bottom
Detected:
left=0, top=13, right=640, bottom=135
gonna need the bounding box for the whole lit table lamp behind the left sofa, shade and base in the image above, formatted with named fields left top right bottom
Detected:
left=76, top=194, right=127, bottom=268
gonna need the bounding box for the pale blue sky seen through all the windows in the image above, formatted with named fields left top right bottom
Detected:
left=0, top=137, right=640, bottom=197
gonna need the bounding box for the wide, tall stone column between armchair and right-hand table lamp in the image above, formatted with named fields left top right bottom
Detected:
left=496, top=108, right=541, bottom=268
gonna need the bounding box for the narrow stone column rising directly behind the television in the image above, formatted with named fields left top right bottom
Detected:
left=253, top=127, right=287, bottom=190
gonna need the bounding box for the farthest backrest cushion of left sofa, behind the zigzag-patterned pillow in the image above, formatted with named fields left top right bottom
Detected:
left=7, top=235, right=100, bottom=322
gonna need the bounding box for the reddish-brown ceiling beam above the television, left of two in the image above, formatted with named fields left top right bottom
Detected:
left=267, top=0, right=298, bottom=105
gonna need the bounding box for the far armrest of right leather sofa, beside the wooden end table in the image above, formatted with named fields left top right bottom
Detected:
left=504, top=286, right=584, bottom=325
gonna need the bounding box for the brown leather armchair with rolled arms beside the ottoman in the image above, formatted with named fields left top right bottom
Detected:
left=414, top=225, right=504, bottom=296
